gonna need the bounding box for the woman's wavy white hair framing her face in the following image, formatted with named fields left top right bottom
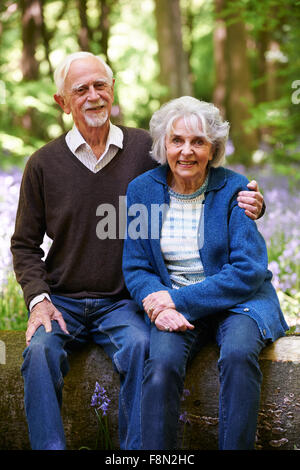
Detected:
left=150, top=96, right=229, bottom=167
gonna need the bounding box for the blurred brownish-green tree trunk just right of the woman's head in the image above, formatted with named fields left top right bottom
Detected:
left=213, top=0, right=258, bottom=165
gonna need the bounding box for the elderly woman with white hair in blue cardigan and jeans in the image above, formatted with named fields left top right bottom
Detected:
left=123, top=97, right=288, bottom=450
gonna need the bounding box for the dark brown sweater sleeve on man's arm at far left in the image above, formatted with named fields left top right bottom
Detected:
left=11, top=158, right=50, bottom=307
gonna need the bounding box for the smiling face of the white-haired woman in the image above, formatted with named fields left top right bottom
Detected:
left=166, top=118, right=213, bottom=189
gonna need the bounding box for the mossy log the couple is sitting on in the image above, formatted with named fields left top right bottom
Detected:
left=0, top=331, right=300, bottom=450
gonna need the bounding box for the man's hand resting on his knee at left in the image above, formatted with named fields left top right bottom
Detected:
left=26, top=299, right=69, bottom=346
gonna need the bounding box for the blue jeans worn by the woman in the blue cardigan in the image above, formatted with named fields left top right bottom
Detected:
left=142, top=313, right=265, bottom=450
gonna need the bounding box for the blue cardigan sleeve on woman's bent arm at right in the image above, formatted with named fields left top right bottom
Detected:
left=169, top=196, right=270, bottom=321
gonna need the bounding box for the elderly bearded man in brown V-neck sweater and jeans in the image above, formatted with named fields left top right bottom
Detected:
left=11, top=52, right=262, bottom=449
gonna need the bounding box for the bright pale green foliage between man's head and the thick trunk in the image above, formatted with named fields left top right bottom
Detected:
left=109, top=0, right=164, bottom=129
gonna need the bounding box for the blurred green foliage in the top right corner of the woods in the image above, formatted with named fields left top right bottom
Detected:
left=222, top=0, right=300, bottom=165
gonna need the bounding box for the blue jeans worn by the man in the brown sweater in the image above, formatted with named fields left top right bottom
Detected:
left=22, top=295, right=149, bottom=450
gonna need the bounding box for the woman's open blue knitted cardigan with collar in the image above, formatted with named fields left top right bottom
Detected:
left=123, top=165, right=288, bottom=341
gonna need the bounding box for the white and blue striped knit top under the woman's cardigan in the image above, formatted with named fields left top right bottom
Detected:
left=160, top=176, right=208, bottom=289
